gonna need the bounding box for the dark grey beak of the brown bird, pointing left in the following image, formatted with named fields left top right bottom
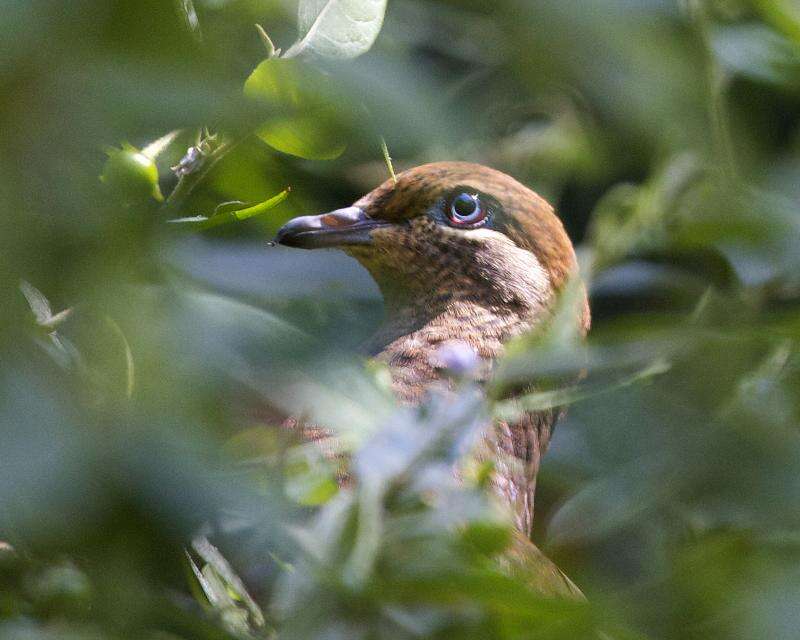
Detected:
left=275, top=207, right=387, bottom=249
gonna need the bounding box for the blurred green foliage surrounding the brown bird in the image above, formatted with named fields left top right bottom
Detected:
left=0, top=0, right=800, bottom=640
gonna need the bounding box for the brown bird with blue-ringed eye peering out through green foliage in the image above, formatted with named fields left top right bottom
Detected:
left=275, top=161, right=591, bottom=592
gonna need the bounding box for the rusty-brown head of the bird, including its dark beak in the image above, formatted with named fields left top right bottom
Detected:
left=276, top=162, right=588, bottom=330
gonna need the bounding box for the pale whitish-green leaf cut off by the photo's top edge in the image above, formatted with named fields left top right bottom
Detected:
left=285, top=0, right=386, bottom=58
